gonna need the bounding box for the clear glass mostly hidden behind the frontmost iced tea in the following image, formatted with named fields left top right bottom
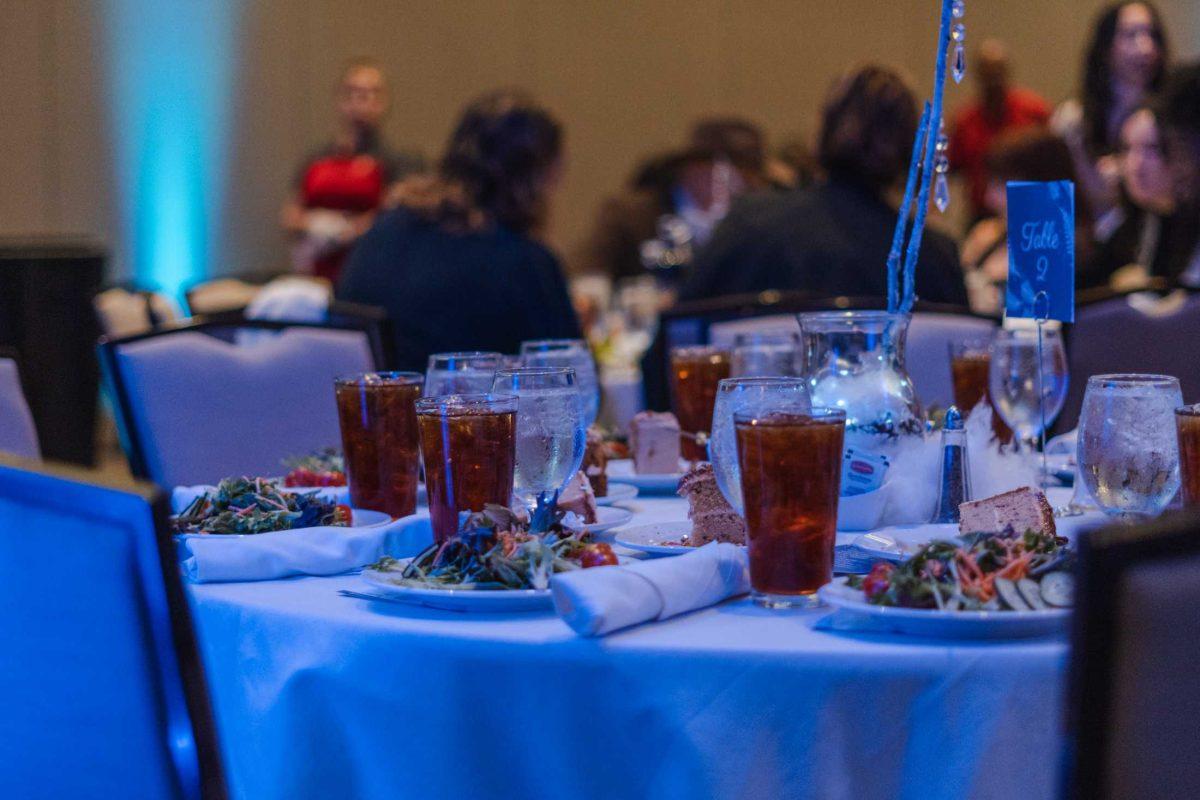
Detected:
left=708, top=378, right=810, bottom=513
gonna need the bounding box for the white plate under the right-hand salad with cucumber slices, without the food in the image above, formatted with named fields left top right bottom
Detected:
left=817, top=578, right=1070, bottom=639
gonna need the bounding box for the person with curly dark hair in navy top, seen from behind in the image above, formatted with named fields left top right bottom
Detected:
left=337, top=91, right=580, bottom=371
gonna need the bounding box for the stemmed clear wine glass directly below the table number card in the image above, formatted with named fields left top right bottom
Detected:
left=988, top=327, right=1067, bottom=450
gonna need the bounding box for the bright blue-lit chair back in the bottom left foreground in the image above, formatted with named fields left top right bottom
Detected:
left=0, top=458, right=226, bottom=800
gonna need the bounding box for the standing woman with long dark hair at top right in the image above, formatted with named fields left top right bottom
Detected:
left=1050, top=0, right=1169, bottom=227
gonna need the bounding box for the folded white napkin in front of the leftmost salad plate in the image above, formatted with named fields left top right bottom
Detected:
left=179, top=513, right=433, bottom=583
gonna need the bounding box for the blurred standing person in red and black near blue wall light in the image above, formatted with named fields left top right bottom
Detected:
left=280, top=59, right=425, bottom=281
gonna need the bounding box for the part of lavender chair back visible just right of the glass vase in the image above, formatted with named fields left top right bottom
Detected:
left=905, top=312, right=996, bottom=414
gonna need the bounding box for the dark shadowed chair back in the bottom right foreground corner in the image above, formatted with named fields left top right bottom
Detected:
left=1063, top=515, right=1200, bottom=800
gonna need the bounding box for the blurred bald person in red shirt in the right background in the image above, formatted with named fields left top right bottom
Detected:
left=949, top=38, right=1050, bottom=219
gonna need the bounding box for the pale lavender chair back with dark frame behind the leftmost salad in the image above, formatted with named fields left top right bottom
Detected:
left=101, top=320, right=376, bottom=487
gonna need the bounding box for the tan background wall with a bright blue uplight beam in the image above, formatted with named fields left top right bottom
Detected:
left=0, top=0, right=1200, bottom=297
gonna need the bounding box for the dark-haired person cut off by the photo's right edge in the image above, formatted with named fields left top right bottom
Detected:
left=1159, top=61, right=1200, bottom=288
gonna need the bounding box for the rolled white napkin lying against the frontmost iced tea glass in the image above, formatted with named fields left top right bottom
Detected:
left=550, top=542, right=750, bottom=636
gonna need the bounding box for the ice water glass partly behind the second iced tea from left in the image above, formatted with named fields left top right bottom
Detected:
left=492, top=367, right=587, bottom=511
